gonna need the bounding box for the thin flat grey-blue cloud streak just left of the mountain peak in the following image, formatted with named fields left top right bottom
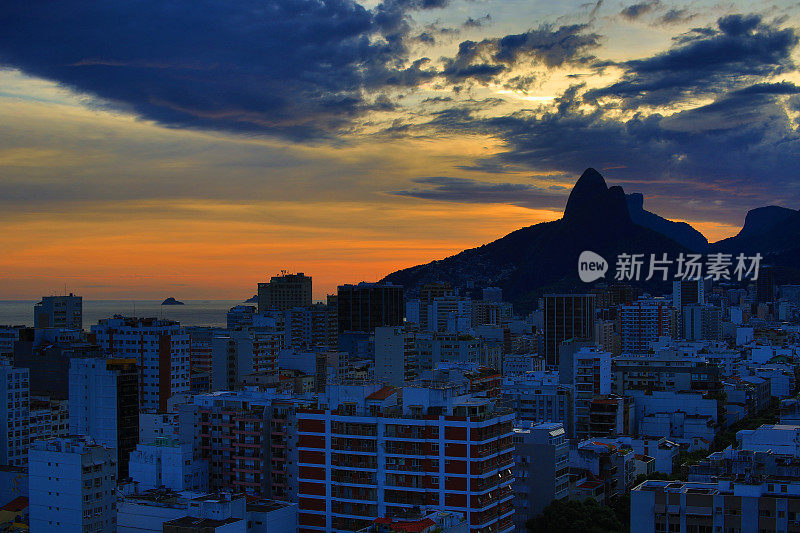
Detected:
left=390, top=176, right=569, bottom=209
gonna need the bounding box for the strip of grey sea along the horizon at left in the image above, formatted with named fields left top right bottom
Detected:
left=0, top=298, right=247, bottom=330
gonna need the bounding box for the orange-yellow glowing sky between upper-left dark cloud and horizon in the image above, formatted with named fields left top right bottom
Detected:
left=0, top=74, right=737, bottom=299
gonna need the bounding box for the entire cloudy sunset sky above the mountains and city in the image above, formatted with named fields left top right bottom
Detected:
left=0, top=0, right=800, bottom=299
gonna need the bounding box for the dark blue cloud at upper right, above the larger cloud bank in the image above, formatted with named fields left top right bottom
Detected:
left=586, top=15, right=798, bottom=108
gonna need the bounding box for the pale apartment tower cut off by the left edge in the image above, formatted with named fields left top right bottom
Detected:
left=0, top=365, right=30, bottom=466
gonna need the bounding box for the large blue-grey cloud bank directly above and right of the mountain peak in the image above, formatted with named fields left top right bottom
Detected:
left=418, top=67, right=800, bottom=223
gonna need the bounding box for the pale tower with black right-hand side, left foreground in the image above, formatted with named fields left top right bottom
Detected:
left=69, top=358, right=139, bottom=479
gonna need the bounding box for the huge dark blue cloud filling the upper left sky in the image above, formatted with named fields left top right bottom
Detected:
left=0, top=0, right=445, bottom=139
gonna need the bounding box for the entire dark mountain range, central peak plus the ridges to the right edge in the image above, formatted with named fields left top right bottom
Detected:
left=383, top=168, right=800, bottom=312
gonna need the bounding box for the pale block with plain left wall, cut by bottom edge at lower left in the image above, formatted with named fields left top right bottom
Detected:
left=28, top=436, right=117, bottom=533
